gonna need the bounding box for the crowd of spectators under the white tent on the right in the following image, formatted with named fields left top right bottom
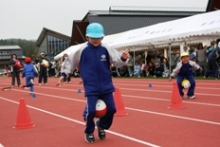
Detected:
left=112, top=39, right=220, bottom=79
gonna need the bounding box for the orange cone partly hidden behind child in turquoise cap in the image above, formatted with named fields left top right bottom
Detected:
left=114, top=88, right=128, bottom=116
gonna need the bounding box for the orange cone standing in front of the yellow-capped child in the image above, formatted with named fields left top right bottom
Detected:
left=168, top=83, right=185, bottom=109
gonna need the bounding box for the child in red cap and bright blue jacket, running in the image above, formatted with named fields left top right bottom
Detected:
left=22, top=57, right=38, bottom=98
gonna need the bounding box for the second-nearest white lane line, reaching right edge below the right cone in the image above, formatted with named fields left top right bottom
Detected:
left=3, top=89, right=220, bottom=125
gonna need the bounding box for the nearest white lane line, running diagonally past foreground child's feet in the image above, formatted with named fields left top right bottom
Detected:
left=0, top=97, right=160, bottom=147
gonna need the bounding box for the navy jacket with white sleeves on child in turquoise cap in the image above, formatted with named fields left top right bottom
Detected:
left=64, top=42, right=126, bottom=96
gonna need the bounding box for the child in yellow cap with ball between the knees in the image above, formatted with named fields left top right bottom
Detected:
left=169, top=52, right=202, bottom=99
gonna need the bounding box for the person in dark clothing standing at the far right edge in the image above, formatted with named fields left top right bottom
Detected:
left=205, top=39, right=220, bottom=79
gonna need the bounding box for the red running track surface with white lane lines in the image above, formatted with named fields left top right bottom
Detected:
left=0, top=78, right=220, bottom=147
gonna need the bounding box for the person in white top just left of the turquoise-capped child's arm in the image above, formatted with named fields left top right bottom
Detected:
left=56, top=53, right=70, bottom=86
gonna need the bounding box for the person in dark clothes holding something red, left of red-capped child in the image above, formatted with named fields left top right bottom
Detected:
left=10, top=54, right=21, bottom=87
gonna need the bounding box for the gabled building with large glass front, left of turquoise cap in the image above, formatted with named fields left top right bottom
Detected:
left=36, top=28, right=71, bottom=58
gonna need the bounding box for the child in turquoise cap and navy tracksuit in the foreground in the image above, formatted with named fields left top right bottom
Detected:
left=63, top=23, right=129, bottom=143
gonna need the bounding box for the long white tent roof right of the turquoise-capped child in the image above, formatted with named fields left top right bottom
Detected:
left=111, top=11, right=220, bottom=49
